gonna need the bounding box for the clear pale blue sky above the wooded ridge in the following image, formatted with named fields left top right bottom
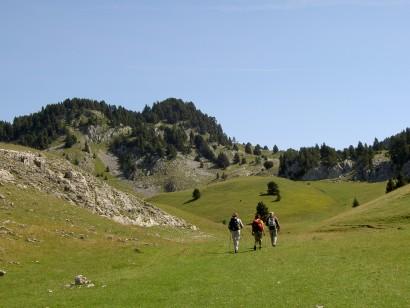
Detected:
left=0, top=0, right=410, bottom=149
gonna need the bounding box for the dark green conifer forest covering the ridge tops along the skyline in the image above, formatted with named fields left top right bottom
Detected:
left=0, top=98, right=410, bottom=180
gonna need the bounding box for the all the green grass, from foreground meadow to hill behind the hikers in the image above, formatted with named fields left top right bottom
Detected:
left=0, top=177, right=410, bottom=307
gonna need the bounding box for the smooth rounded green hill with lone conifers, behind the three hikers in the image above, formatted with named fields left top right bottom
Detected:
left=150, top=177, right=384, bottom=230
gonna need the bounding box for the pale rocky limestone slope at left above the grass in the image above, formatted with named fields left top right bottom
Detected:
left=0, top=149, right=194, bottom=228
